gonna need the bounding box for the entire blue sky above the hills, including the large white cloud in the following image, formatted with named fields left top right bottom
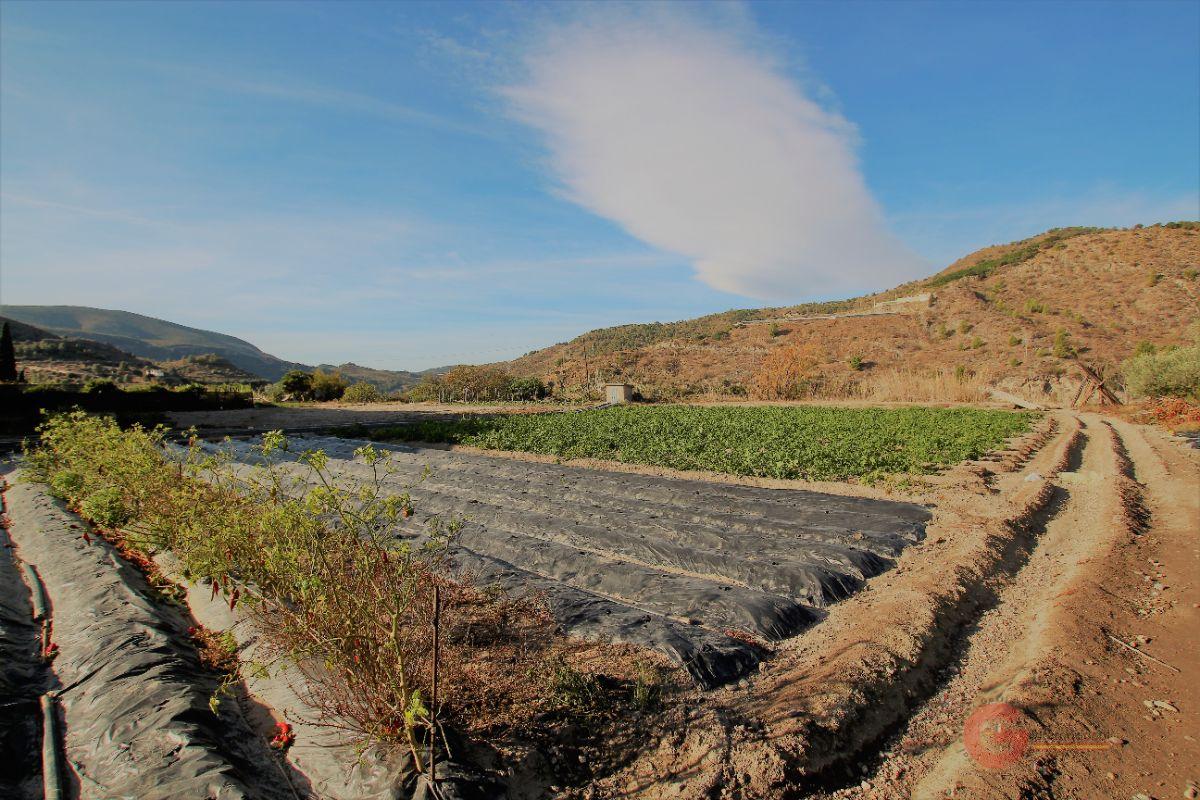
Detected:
left=0, top=0, right=1200, bottom=368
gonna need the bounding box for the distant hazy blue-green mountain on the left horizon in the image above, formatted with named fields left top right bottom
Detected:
left=0, top=306, right=437, bottom=392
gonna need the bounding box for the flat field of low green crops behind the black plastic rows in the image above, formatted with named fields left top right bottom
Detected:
left=372, top=405, right=1036, bottom=480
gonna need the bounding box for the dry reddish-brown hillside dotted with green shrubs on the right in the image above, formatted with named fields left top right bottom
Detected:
left=502, top=223, right=1200, bottom=399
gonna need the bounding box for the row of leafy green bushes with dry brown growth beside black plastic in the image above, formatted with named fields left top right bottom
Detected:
left=26, top=411, right=566, bottom=770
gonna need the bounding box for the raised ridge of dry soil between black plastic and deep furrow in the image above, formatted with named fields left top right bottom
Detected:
left=580, top=415, right=1082, bottom=798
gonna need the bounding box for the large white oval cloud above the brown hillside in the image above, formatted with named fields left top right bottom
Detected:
left=502, top=8, right=925, bottom=301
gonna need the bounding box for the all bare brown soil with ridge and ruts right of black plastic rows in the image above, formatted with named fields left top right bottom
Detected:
left=594, top=414, right=1200, bottom=800
